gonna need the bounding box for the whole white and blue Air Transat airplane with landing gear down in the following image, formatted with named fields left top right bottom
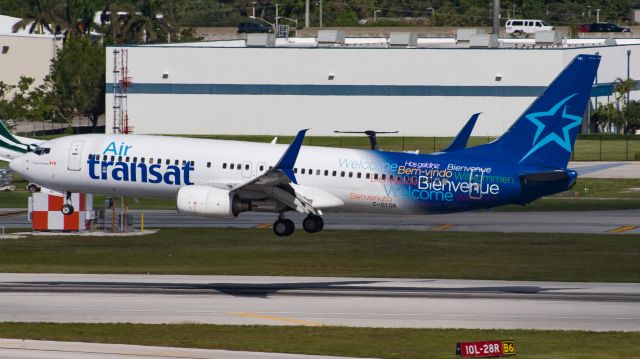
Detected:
left=0, top=55, right=600, bottom=236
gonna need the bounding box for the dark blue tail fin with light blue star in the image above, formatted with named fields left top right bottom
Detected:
left=487, top=55, right=600, bottom=168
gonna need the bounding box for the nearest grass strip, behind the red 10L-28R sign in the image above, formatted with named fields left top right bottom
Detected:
left=0, top=323, right=640, bottom=359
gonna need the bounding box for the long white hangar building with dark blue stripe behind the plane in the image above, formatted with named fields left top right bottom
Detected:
left=106, top=35, right=640, bottom=136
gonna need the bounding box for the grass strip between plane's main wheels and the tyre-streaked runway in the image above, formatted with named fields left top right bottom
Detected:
left=0, top=228, right=640, bottom=282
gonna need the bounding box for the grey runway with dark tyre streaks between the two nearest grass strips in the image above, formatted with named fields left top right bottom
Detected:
left=0, top=274, right=640, bottom=331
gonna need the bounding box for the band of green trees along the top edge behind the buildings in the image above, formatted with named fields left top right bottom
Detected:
left=0, top=0, right=637, bottom=32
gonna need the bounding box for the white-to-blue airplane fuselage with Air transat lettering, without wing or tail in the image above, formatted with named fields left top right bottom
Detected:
left=8, top=135, right=552, bottom=213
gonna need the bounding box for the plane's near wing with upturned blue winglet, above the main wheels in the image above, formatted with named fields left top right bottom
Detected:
left=231, top=130, right=344, bottom=215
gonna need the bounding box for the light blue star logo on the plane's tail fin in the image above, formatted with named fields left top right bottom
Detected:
left=520, top=93, right=582, bottom=162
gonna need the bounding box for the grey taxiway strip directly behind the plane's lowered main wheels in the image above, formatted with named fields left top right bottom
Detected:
left=0, top=209, right=640, bottom=234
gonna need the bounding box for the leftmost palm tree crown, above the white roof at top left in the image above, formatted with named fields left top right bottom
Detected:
left=12, top=0, right=65, bottom=34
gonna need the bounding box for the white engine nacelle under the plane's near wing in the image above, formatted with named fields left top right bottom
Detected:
left=177, top=186, right=251, bottom=218
